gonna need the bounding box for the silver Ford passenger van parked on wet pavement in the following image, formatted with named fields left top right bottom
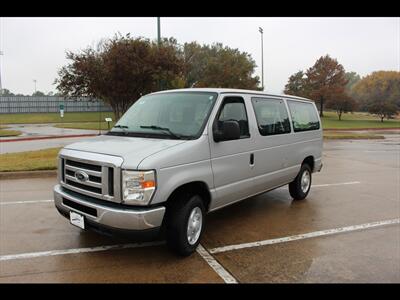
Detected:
left=54, top=88, right=322, bottom=256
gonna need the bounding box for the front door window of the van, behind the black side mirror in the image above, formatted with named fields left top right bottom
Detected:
left=217, top=97, right=250, bottom=139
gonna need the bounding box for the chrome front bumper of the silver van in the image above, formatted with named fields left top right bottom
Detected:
left=54, top=184, right=165, bottom=231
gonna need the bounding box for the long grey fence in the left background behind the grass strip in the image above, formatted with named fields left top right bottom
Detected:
left=0, top=96, right=112, bottom=114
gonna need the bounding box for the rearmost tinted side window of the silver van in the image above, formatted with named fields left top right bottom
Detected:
left=287, top=100, right=320, bottom=132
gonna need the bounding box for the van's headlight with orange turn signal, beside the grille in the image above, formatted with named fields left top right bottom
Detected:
left=122, top=170, right=156, bottom=205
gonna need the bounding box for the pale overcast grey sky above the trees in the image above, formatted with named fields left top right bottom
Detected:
left=0, top=17, right=400, bottom=94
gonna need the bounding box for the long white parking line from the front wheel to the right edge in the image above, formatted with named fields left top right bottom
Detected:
left=209, top=218, right=400, bottom=254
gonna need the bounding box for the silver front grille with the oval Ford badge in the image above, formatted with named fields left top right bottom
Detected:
left=60, top=157, right=118, bottom=202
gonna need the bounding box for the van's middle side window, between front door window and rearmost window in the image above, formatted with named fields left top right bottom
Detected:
left=251, top=98, right=290, bottom=136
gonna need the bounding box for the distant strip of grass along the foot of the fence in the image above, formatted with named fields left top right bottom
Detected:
left=0, top=112, right=114, bottom=124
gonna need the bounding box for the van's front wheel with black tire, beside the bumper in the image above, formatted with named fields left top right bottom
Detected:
left=166, top=193, right=205, bottom=256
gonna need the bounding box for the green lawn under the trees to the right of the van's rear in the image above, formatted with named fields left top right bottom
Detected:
left=322, top=112, right=400, bottom=129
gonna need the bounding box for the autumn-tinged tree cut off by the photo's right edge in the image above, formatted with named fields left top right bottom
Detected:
left=353, top=71, right=400, bottom=122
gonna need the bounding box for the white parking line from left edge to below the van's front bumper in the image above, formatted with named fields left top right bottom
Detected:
left=0, top=241, right=165, bottom=261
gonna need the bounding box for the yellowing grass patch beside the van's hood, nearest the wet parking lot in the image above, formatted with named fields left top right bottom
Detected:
left=0, top=148, right=61, bottom=172
